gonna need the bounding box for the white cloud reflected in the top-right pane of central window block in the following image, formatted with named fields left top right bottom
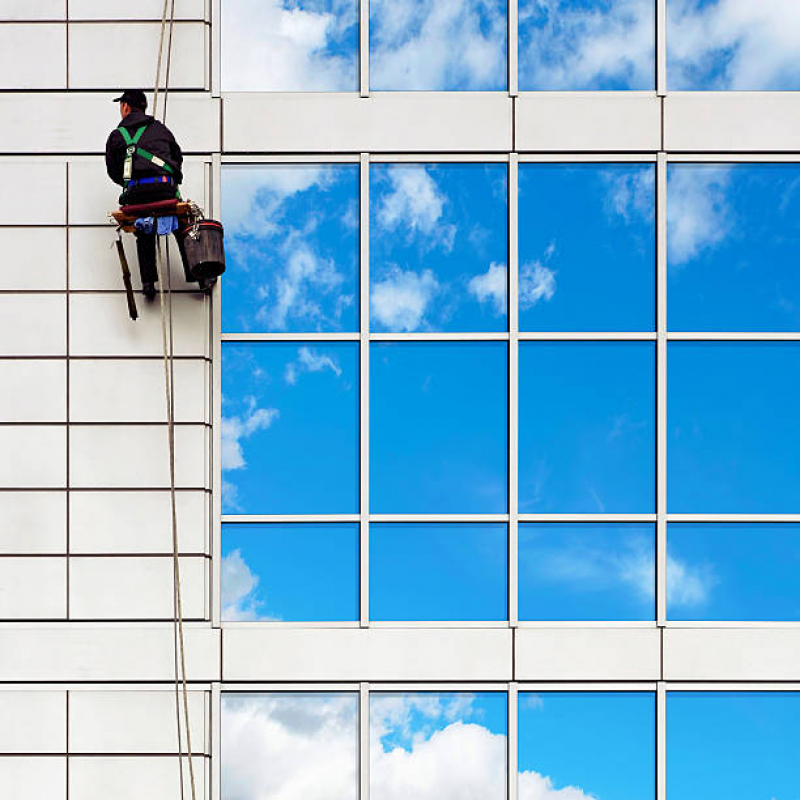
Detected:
left=667, top=165, right=732, bottom=266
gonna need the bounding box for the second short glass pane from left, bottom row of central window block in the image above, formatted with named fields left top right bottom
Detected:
left=369, top=523, right=508, bottom=621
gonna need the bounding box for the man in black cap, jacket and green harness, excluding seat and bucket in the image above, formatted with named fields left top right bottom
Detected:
left=106, top=89, right=188, bottom=299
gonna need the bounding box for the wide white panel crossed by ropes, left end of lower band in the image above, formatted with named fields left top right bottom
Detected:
left=0, top=622, right=220, bottom=680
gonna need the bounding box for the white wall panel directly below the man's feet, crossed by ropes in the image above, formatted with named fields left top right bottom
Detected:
left=69, top=293, right=209, bottom=357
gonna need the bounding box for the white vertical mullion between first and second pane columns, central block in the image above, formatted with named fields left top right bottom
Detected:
left=359, top=153, right=370, bottom=627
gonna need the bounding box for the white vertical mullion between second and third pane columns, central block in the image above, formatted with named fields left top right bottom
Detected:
left=507, top=153, right=519, bottom=632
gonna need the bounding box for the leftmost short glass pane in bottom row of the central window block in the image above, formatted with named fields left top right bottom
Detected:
left=222, top=523, right=359, bottom=622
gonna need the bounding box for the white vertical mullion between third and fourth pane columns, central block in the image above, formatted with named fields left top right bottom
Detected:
left=656, top=152, right=667, bottom=625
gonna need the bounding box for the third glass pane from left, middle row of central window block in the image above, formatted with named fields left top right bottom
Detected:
left=519, top=342, right=655, bottom=514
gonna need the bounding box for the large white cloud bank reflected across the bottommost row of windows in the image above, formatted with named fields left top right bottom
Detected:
left=222, top=694, right=591, bottom=800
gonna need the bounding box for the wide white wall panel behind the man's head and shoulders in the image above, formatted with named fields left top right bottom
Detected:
left=0, top=94, right=220, bottom=155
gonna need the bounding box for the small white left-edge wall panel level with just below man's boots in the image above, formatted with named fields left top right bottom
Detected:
left=0, top=294, right=67, bottom=356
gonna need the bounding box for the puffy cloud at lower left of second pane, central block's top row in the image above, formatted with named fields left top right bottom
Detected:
left=370, top=267, right=439, bottom=331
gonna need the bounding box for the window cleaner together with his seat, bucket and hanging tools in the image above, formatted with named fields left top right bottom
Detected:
left=106, top=89, right=225, bottom=319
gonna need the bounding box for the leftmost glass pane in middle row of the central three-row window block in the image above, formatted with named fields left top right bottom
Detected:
left=221, top=342, right=359, bottom=514
